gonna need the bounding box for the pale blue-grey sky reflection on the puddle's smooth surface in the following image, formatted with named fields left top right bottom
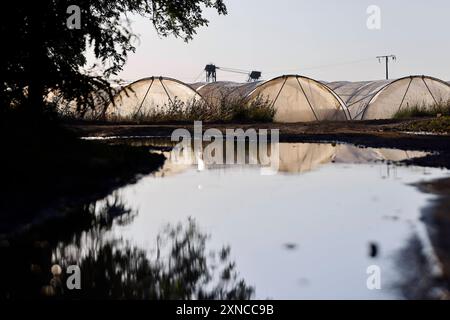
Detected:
left=104, top=144, right=447, bottom=299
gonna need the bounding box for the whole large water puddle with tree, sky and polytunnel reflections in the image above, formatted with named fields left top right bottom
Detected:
left=4, top=139, right=449, bottom=299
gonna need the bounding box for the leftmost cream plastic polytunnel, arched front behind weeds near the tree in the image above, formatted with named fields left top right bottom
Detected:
left=108, top=77, right=202, bottom=119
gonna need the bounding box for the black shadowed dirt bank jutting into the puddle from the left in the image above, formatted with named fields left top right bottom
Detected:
left=0, top=137, right=165, bottom=236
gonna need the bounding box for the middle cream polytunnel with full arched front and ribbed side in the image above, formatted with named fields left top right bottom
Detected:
left=192, top=75, right=349, bottom=123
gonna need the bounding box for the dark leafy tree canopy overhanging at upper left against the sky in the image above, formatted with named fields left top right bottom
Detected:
left=0, top=0, right=227, bottom=117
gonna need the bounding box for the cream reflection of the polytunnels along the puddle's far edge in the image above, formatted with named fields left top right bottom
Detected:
left=142, top=141, right=428, bottom=176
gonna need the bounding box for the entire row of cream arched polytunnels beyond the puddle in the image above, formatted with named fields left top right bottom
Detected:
left=85, top=75, right=450, bottom=123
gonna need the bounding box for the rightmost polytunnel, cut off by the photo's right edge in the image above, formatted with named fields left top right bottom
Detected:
left=327, top=76, right=450, bottom=120
